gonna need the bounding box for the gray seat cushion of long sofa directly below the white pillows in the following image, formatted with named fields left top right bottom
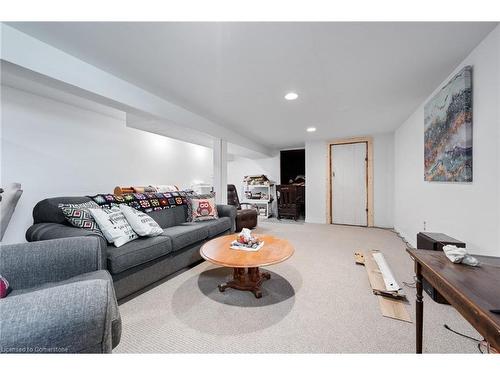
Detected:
left=107, top=236, right=172, bottom=274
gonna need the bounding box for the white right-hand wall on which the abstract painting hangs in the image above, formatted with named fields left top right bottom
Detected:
left=395, top=27, right=500, bottom=256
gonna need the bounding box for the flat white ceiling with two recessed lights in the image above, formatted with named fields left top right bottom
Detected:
left=9, top=22, right=497, bottom=149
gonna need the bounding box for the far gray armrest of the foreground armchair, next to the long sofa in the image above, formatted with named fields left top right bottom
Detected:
left=0, top=236, right=103, bottom=289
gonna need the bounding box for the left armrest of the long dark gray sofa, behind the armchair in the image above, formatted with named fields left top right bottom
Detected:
left=26, top=223, right=108, bottom=268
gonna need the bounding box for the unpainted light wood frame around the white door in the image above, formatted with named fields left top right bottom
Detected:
left=326, top=137, right=373, bottom=227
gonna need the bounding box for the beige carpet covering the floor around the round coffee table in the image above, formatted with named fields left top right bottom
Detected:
left=115, top=222, right=479, bottom=353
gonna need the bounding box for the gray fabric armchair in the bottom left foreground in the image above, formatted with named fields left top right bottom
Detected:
left=0, top=237, right=121, bottom=353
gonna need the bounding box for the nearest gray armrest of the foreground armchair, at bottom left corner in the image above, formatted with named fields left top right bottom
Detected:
left=0, top=279, right=116, bottom=353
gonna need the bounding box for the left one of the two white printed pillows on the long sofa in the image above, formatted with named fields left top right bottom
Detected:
left=89, top=207, right=138, bottom=247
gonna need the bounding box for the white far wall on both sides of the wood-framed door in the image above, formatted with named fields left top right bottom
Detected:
left=306, top=133, right=394, bottom=228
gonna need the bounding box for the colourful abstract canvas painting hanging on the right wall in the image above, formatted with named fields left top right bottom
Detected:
left=424, top=66, right=472, bottom=182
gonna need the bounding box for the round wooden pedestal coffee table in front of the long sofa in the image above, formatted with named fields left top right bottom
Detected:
left=200, top=234, right=294, bottom=298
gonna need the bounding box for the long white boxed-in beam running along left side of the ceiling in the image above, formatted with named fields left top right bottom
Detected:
left=0, top=22, right=271, bottom=155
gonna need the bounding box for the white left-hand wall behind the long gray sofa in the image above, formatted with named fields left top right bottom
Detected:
left=1, top=86, right=213, bottom=243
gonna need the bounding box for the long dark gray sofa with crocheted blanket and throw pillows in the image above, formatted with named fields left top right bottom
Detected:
left=26, top=197, right=236, bottom=299
